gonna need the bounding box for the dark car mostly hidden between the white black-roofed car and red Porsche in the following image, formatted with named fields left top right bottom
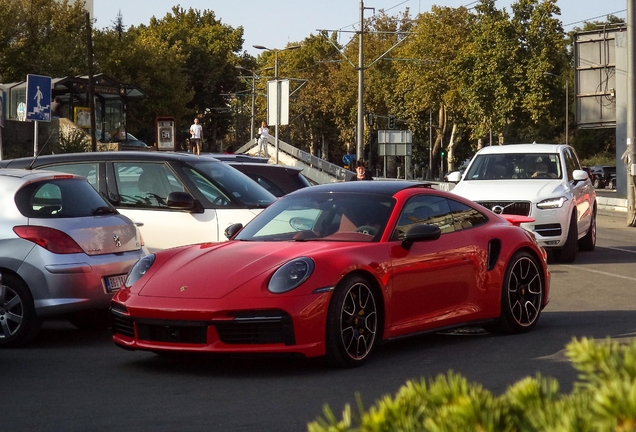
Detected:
left=228, top=162, right=312, bottom=197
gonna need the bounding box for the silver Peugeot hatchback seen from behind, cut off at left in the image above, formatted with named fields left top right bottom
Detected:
left=0, top=169, right=148, bottom=347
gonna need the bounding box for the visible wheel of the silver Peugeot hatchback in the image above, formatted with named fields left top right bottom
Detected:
left=0, top=274, right=42, bottom=347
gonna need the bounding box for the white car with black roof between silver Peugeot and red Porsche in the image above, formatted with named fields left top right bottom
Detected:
left=0, top=151, right=276, bottom=252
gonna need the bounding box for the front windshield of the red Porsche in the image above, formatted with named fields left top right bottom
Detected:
left=236, top=189, right=395, bottom=242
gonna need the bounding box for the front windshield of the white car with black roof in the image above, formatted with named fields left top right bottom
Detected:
left=184, top=160, right=276, bottom=208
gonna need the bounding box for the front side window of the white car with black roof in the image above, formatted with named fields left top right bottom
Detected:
left=113, top=162, right=185, bottom=209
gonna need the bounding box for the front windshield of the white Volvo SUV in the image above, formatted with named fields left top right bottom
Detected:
left=464, top=153, right=563, bottom=180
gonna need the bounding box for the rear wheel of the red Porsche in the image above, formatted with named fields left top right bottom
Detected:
left=497, top=251, right=543, bottom=333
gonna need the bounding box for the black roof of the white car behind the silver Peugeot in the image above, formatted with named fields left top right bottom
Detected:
left=1, top=151, right=221, bottom=167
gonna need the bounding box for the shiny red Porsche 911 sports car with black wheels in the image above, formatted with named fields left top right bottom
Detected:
left=111, top=181, right=550, bottom=367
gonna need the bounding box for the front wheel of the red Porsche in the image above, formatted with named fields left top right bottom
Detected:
left=326, top=276, right=379, bottom=367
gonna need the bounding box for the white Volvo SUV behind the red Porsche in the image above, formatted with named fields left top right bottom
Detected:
left=448, top=144, right=596, bottom=262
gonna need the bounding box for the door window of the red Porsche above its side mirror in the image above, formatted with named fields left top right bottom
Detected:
left=391, top=195, right=455, bottom=240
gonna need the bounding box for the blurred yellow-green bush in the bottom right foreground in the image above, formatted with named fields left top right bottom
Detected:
left=308, top=338, right=636, bottom=432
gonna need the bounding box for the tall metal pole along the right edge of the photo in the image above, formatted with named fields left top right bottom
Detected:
left=626, top=1, right=636, bottom=227
